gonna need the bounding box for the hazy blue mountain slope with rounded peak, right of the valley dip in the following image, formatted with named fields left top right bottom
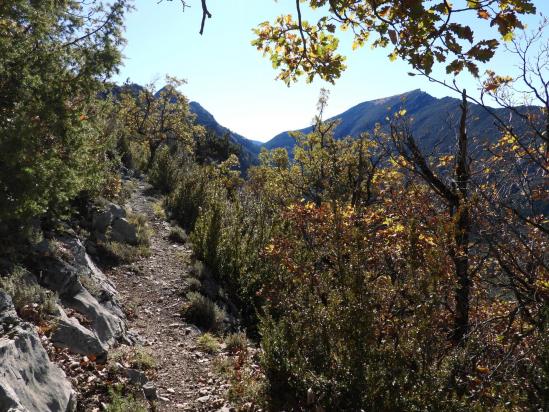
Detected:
left=264, top=89, right=524, bottom=151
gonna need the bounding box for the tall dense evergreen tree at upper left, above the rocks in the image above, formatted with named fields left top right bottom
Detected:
left=0, top=0, right=126, bottom=223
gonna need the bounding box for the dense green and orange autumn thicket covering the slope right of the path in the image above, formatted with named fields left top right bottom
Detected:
left=146, top=89, right=549, bottom=410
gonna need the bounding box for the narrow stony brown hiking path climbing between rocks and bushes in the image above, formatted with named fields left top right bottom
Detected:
left=107, top=181, right=230, bottom=411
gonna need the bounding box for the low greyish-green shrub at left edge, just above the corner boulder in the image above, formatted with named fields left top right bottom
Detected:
left=0, top=267, right=58, bottom=320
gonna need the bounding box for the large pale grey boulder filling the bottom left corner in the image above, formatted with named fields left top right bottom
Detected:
left=0, top=290, right=76, bottom=412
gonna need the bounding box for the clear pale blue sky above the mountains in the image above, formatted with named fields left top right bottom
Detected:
left=116, top=0, right=549, bottom=141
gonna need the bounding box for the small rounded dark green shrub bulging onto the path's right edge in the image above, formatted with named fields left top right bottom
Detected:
left=181, top=292, right=225, bottom=332
